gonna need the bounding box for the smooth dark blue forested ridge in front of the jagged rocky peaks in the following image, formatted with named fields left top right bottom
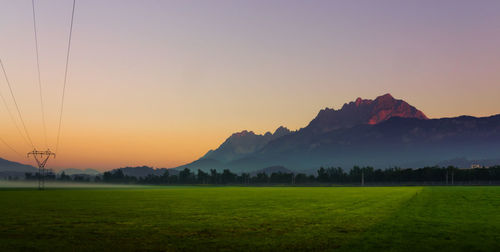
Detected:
left=252, top=115, right=500, bottom=170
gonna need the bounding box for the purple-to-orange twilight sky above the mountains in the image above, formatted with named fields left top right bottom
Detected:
left=0, top=0, right=500, bottom=170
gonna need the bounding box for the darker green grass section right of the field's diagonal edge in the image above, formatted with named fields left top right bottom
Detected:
left=344, top=187, right=500, bottom=251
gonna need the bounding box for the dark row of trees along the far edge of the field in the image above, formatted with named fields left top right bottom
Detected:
left=97, top=166, right=500, bottom=185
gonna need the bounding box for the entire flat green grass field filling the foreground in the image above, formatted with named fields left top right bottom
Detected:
left=0, top=187, right=500, bottom=251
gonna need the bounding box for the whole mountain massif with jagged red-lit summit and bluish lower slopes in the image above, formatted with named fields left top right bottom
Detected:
left=179, top=94, right=500, bottom=172
